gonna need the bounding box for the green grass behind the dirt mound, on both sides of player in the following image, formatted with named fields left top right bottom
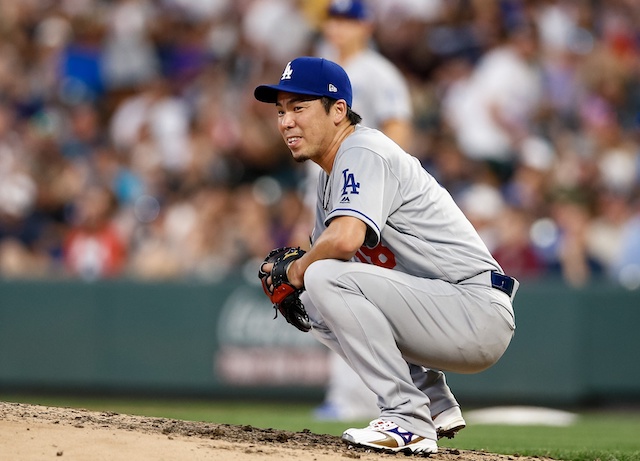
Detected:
left=0, top=396, right=640, bottom=461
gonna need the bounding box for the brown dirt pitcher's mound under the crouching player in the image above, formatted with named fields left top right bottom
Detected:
left=0, top=402, right=556, bottom=461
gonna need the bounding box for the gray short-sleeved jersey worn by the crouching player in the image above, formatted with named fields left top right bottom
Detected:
left=313, top=125, right=501, bottom=282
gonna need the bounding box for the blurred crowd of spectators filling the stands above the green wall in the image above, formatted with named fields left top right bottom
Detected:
left=0, top=0, right=640, bottom=289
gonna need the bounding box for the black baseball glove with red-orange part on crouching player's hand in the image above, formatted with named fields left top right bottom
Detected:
left=258, top=247, right=311, bottom=332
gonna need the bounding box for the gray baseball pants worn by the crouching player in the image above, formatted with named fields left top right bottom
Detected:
left=302, top=259, right=515, bottom=440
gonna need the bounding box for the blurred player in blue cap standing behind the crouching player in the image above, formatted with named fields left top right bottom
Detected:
left=305, top=0, right=413, bottom=421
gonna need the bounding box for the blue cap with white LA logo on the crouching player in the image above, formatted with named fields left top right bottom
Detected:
left=253, top=56, right=353, bottom=107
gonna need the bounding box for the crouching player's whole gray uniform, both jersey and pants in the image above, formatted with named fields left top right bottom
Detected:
left=301, top=126, right=515, bottom=440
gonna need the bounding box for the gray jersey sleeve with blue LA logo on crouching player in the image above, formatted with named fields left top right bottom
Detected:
left=325, top=147, right=398, bottom=248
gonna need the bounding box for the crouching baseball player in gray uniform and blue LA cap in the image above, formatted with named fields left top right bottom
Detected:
left=254, top=57, right=518, bottom=455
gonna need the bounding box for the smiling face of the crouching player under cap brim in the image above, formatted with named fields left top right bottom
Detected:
left=276, top=92, right=336, bottom=162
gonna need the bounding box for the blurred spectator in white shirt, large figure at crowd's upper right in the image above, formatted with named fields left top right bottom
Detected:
left=443, top=18, right=543, bottom=182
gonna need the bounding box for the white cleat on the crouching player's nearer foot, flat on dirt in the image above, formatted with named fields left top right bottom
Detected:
left=342, top=419, right=438, bottom=456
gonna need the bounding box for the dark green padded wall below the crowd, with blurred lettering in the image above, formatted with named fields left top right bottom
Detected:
left=0, top=276, right=640, bottom=405
